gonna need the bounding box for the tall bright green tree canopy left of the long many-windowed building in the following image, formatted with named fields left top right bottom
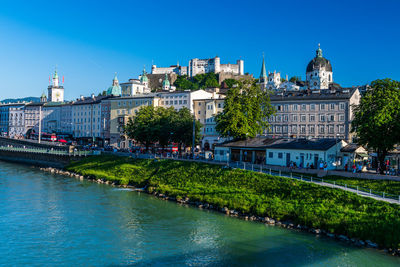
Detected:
left=215, top=80, right=275, bottom=140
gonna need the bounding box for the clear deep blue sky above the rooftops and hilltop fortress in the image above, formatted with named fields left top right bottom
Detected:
left=0, top=0, right=400, bottom=99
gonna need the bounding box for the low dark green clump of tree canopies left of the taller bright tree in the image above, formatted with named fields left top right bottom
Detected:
left=125, top=106, right=202, bottom=152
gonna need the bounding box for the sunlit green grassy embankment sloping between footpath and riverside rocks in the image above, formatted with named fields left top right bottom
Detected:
left=67, top=156, right=400, bottom=248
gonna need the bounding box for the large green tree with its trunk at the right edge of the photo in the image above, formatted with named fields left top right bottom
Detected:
left=352, top=79, right=400, bottom=171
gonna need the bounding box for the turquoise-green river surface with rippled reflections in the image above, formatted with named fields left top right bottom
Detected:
left=0, top=162, right=400, bottom=266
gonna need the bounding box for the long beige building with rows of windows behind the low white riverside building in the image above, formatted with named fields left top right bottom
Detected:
left=264, top=88, right=360, bottom=142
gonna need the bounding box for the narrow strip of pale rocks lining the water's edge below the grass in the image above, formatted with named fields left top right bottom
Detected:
left=39, top=167, right=400, bottom=256
